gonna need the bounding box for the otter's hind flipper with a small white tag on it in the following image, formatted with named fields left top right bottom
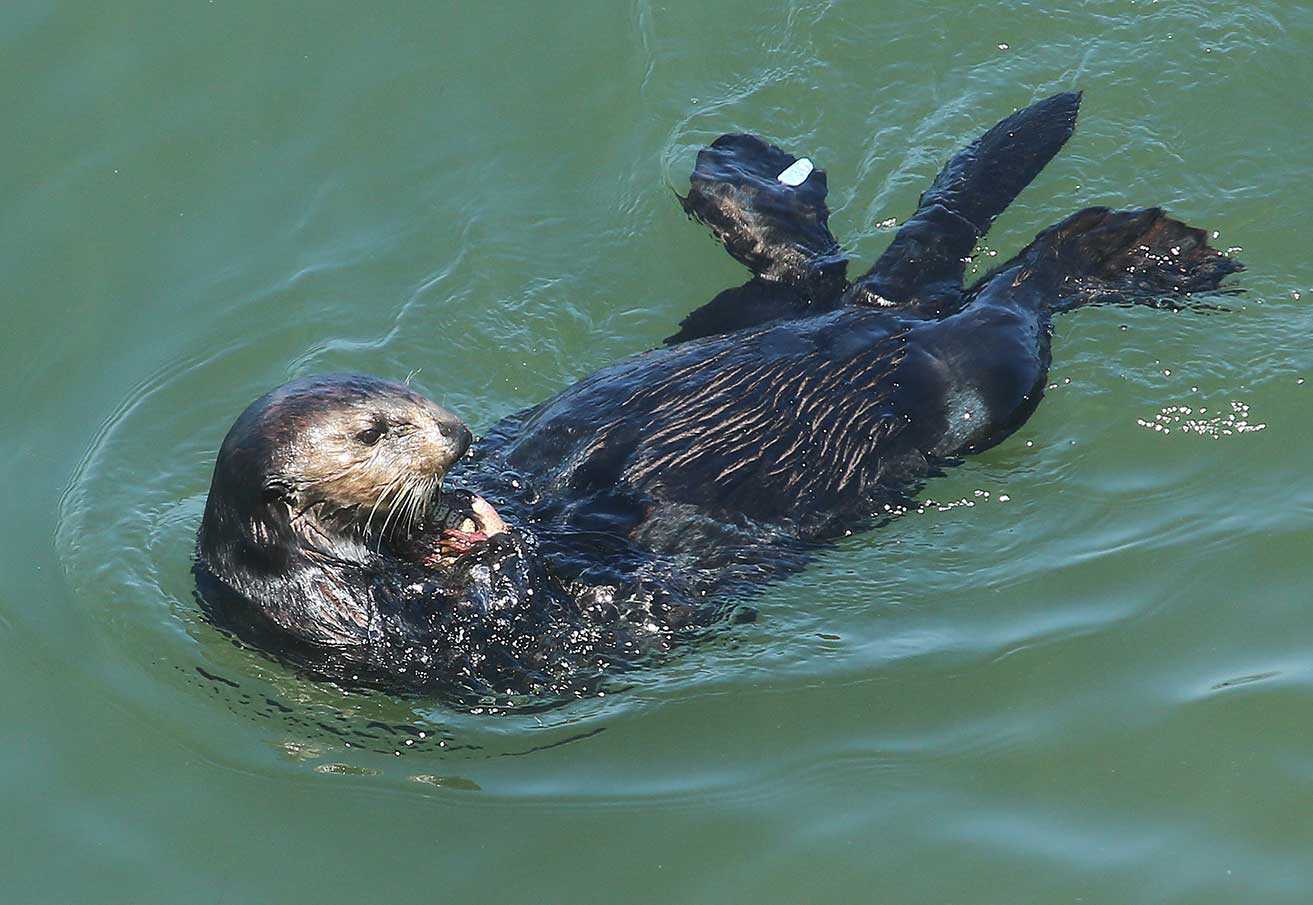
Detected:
left=680, top=134, right=847, bottom=296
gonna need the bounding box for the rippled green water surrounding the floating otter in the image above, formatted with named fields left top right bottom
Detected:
left=0, top=0, right=1313, bottom=905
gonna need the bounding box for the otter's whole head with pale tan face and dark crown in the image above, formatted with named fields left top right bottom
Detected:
left=200, top=374, right=471, bottom=573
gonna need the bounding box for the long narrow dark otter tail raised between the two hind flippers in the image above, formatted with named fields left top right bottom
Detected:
left=847, top=92, right=1081, bottom=317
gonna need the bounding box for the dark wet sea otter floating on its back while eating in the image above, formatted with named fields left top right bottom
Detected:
left=197, top=93, right=1241, bottom=696
